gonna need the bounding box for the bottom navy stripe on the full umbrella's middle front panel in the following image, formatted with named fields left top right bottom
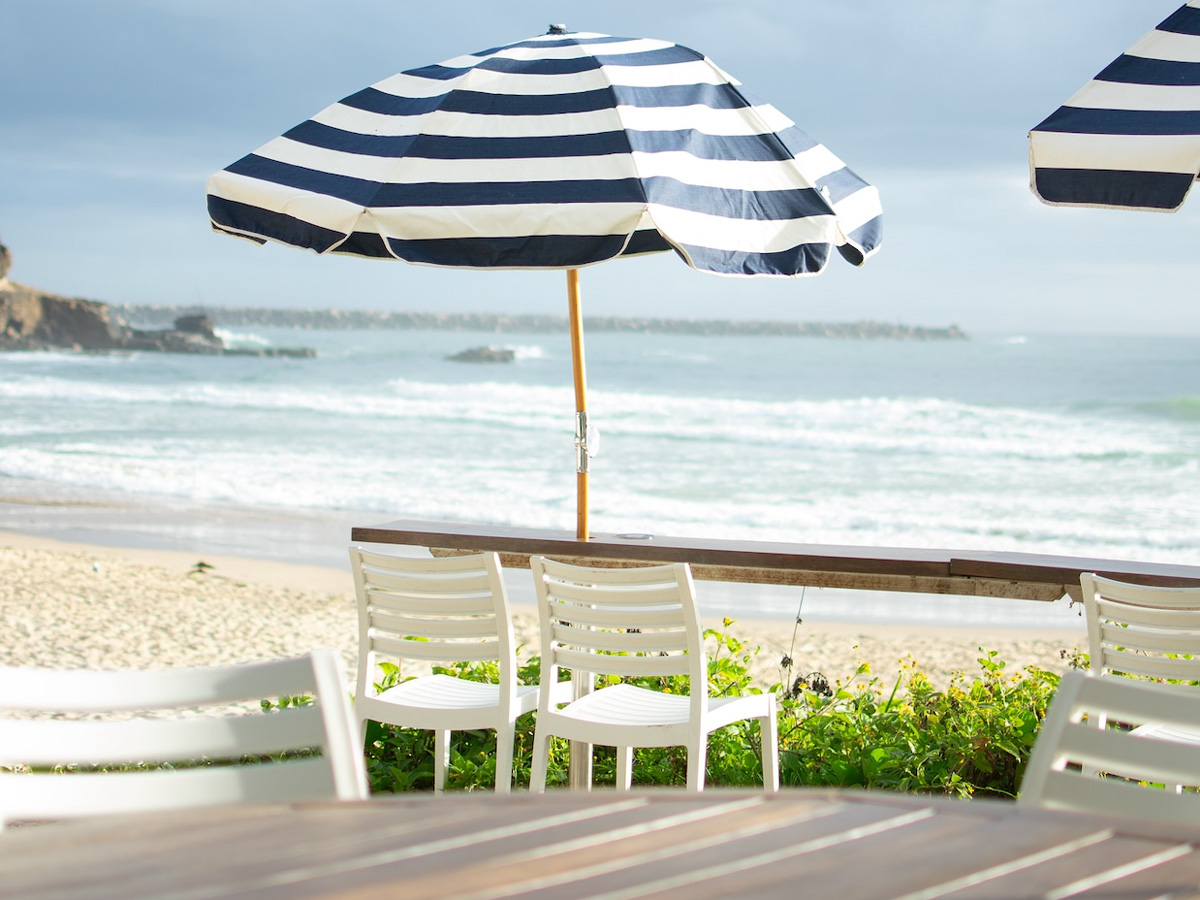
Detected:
left=388, top=234, right=625, bottom=269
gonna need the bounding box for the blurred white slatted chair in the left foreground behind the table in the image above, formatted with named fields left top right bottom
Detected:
left=0, top=650, right=368, bottom=828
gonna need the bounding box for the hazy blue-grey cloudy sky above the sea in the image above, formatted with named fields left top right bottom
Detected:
left=0, top=0, right=1200, bottom=335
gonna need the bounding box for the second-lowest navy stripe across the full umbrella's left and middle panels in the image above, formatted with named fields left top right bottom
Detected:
left=218, top=154, right=646, bottom=208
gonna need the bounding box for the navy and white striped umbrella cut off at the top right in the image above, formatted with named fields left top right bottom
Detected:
left=1030, top=0, right=1200, bottom=211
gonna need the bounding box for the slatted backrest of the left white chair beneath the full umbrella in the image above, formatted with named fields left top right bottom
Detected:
left=350, top=545, right=516, bottom=697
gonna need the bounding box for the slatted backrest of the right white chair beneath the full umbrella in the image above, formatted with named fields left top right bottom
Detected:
left=529, top=557, right=708, bottom=702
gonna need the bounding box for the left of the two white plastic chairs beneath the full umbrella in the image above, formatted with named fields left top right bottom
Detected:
left=350, top=546, right=538, bottom=793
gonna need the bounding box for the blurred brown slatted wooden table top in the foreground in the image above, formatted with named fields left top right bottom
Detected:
left=0, top=790, right=1200, bottom=900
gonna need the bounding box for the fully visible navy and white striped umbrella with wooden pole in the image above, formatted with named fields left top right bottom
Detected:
left=208, top=25, right=881, bottom=539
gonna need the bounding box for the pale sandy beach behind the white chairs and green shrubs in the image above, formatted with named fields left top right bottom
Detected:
left=0, top=532, right=1086, bottom=688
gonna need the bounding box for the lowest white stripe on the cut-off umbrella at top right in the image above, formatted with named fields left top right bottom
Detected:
left=1030, top=131, right=1200, bottom=175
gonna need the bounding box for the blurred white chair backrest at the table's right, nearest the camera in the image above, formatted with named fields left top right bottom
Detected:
left=1020, top=671, right=1200, bottom=824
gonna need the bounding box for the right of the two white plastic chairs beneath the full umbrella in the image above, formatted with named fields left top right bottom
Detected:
left=529, top=557, right=779, bottom=792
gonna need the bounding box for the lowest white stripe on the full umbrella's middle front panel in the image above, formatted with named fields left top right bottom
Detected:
left=371, top=203, right=644, bottom=240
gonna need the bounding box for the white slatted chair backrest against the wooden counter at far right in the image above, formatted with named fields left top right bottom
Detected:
left=1079, top=572, right=1200, bottom=680
